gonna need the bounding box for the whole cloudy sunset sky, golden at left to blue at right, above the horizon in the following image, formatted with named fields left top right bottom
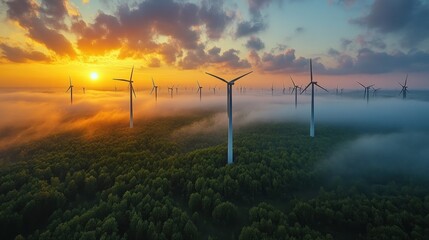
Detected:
left=0, top=0, right=429, bottom=89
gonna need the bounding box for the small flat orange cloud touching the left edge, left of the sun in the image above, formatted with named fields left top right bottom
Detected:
left=0, top=43, right=52, bottom=63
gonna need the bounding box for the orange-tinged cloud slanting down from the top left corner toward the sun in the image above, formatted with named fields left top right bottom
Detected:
left=6, top=0, right=76, bottom=58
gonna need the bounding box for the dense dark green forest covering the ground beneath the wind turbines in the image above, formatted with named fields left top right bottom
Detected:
left=0, top=113, right=429, bottom=240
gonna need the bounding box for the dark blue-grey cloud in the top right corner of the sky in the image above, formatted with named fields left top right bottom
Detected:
left=350, top=0, right=429, bottom=47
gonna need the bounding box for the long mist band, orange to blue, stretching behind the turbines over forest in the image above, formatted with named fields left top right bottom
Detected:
left=0, top=86, right=429, bottom=170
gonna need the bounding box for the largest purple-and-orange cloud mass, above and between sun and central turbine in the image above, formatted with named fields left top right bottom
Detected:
left=72, top=0, right=235, bottom=68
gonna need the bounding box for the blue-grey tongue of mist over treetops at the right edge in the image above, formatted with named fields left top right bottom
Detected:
left=321, top=132, right=429, bottom=179
